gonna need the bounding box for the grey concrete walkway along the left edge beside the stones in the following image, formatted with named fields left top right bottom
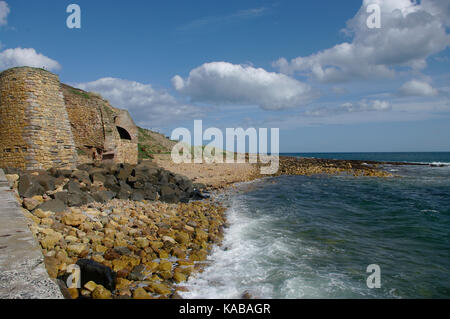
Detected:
left=0, top=169, right=63, bottom=299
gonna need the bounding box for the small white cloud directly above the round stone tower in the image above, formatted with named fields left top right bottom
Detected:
left=0, top=48, right=61, bottom=71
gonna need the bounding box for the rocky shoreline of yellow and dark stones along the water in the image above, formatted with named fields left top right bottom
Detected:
left=0, top=157, right=408, bottom=299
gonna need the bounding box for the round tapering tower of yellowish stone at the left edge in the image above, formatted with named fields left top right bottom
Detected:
left=0, top=67, right=77, bottom=169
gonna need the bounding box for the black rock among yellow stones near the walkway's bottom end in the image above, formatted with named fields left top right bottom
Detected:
left=77, top=259, right=117, bottom=291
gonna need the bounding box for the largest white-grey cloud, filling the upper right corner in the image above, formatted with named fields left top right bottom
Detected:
left=273, top=0, right=450, bottom=82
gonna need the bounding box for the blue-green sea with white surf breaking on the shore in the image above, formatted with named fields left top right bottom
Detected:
left=181, top=152, right=450, bottom=299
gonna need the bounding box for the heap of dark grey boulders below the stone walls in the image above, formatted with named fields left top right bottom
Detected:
left=12, top=161, right=208, bottom=212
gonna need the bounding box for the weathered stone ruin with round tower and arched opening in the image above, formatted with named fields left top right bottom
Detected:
left=0, top=67, right=138, bottom=169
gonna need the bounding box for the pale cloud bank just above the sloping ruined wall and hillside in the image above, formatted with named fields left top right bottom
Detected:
left=75, top=77, right=200, bottom=128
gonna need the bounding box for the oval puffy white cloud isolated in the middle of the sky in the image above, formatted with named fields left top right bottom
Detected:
left=172, top=62, right=316, bottom=110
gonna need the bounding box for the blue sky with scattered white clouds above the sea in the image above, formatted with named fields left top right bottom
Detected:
left=0, top=0, right=450, bottom=152
